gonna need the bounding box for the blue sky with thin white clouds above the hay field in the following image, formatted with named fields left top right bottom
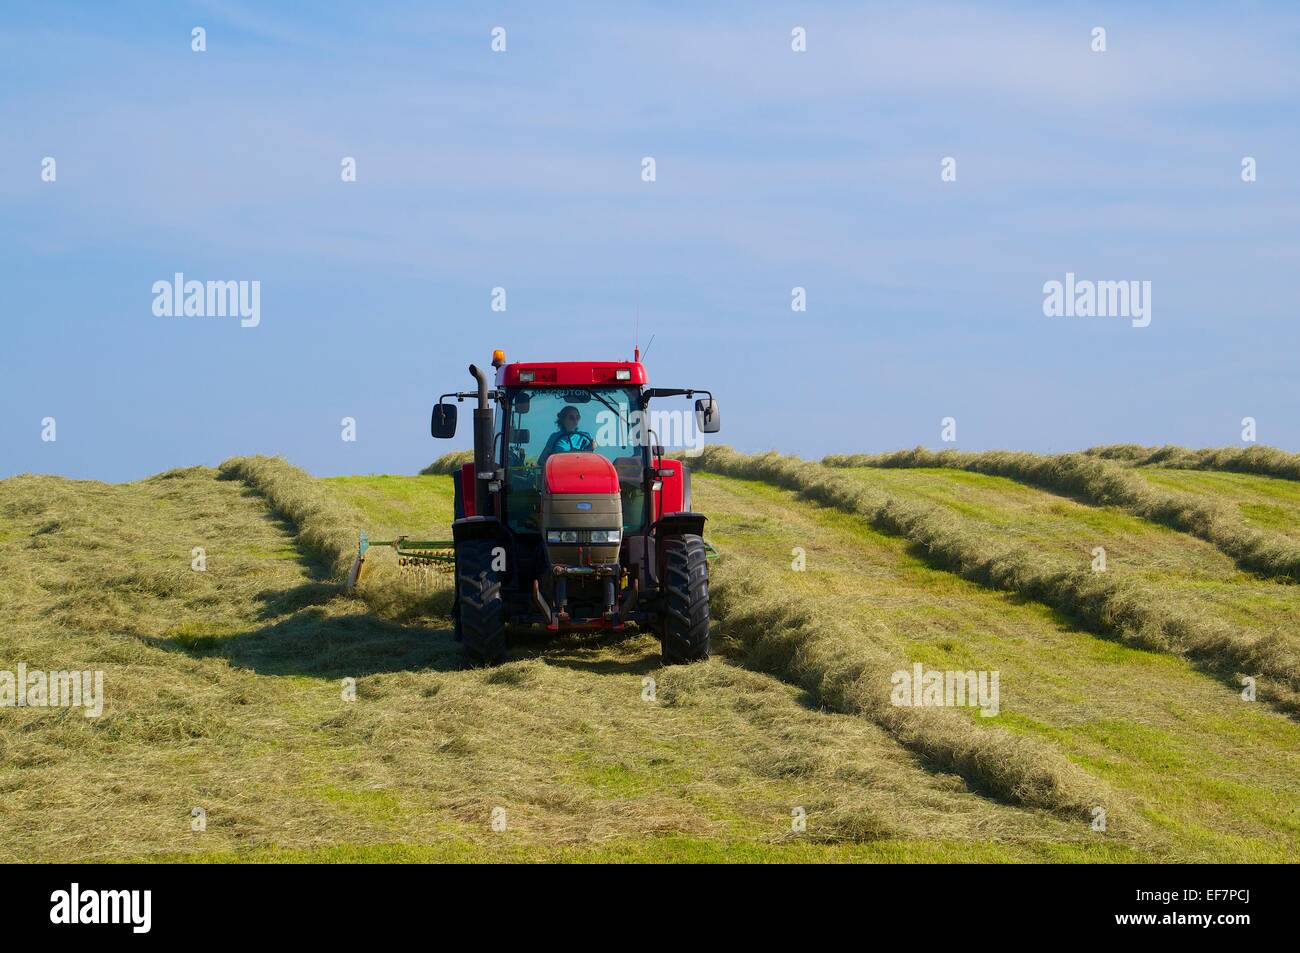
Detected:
left=0, top=3, right=1300, bottom=481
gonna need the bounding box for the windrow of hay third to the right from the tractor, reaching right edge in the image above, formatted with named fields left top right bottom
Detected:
left=823, top=447, right=1300, bottom=581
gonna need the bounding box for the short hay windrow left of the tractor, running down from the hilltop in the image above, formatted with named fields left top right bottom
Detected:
left=218, top=455, right=434, bottom=620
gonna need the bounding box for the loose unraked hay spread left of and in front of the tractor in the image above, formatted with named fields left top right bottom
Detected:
left=0, top=468, right=1102, bottom=861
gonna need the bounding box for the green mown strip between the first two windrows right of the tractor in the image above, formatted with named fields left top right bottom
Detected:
left=696, top=472, right=1300, bottom=861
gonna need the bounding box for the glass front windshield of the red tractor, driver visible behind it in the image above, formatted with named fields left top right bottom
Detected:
left=506, top=387, right=647, bottom=533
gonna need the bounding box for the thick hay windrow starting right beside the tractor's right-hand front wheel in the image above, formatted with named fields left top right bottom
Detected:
left=710, top=554, right=1115, bottom=818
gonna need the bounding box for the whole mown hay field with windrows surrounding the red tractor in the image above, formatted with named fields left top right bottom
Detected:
left=0, top=449, right=1300, bottom=862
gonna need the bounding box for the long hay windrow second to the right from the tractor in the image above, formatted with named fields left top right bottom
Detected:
left=692, top=446, right=1300, bottom=712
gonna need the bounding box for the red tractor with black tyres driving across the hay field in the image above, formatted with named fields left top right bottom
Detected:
left=430, top=351, right=722, bottom=664
